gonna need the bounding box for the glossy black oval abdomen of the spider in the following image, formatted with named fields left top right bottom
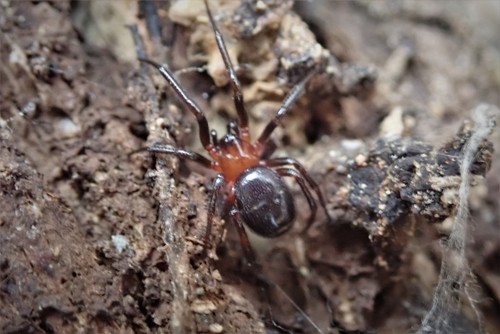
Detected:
left=234, top=165, right=295, bottom=238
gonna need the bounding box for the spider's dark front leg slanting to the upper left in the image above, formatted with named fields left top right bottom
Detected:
left=138, top=58, right=213, bottom=152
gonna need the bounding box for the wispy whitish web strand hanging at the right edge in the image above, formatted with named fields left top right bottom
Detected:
left=417, top=104, right=499, bottom=334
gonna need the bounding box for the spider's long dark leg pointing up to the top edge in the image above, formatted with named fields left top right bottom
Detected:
left=205, top=0, right=250, bottom=142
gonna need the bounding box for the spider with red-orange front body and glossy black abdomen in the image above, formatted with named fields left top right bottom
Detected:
left=139, top=0, right=330, bottom=266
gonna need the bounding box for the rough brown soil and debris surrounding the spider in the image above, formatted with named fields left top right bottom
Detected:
left=0, top=0, right=500, bottom=333
